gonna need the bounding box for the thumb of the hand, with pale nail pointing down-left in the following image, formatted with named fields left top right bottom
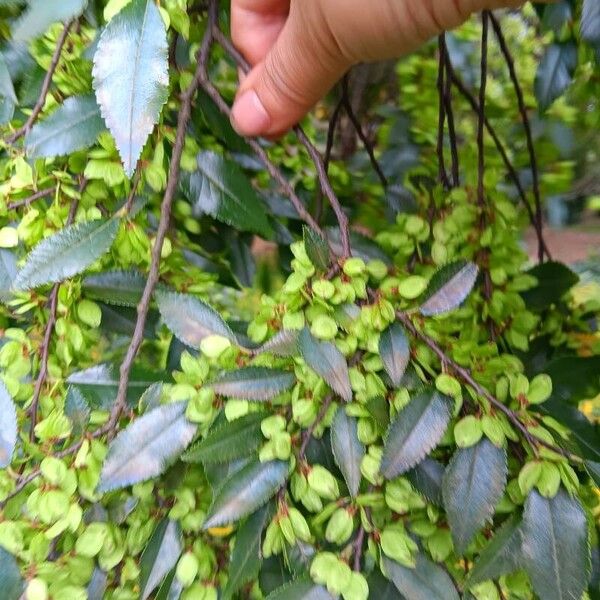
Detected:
left=231, top=2, right=351, bottom=137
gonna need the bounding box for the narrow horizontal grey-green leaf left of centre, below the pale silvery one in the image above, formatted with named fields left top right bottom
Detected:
left=209, top=367, right=296, bottom=400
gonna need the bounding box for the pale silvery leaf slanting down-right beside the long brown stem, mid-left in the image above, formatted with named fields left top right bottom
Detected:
left=154, top=290, right=235, bottom=348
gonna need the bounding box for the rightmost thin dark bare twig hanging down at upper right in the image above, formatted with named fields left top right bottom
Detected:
left=490, top=13, right=547, bottom=262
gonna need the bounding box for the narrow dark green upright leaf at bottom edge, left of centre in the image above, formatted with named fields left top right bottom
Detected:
left=223, top=506, right=271, bottom=600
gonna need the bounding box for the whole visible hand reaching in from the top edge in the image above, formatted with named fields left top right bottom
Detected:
left=231, top=0, right=548, bottom=137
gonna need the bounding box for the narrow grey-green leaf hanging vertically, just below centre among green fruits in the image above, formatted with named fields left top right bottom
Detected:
left=331, top=407, right=365, bottom=498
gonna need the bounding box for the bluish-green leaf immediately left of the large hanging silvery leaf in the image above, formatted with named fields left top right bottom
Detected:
left=25, top=95, right=104, bottom=158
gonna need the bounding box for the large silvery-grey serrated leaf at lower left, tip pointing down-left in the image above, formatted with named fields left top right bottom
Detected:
left=98, top=402, right=196, bottom=492
